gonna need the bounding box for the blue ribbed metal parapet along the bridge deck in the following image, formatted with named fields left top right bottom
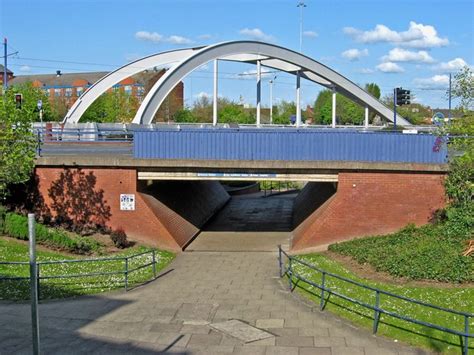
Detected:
left=133, top=128, right=447, bottom=164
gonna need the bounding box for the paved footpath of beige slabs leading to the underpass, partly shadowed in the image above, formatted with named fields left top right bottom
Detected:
left=0, top=252, right=430, bottom=355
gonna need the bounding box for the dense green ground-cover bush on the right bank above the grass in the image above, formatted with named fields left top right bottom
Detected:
left=329, top=222, right=474, bottom=283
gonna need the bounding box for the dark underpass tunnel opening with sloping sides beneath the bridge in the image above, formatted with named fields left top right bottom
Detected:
left=138, top=179, right=337, bottom=251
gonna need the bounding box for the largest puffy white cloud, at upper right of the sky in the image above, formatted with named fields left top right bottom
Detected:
left=343, top=21, right=449, bottom=48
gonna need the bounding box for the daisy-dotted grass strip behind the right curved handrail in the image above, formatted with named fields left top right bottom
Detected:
left=293, top=254, right=474, bottom=354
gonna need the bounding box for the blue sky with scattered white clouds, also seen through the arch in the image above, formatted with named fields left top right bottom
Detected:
left=0, top=0, right=474, bottom=107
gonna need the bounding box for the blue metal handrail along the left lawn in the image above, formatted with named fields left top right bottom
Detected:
left=0, top=250, right=158, bottom=296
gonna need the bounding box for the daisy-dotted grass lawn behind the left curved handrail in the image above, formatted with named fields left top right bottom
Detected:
left=0, top=237, right=174, bottom=300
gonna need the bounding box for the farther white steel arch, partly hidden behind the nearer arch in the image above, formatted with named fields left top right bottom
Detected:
left=63, top=47, right=202, bottom=123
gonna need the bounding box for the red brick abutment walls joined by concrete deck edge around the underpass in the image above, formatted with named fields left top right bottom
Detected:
left=31, top=156, right=447, bottom=251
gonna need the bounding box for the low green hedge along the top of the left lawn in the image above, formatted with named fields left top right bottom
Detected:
left=4, top=213, right=100, bottom=254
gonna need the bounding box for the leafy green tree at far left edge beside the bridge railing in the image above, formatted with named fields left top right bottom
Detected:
left=0, top=84, right=45, bottom=199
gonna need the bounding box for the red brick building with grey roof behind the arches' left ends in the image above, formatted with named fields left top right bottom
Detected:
left=8, top=66, right=184, bottom=121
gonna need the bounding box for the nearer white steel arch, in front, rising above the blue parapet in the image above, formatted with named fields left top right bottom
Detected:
left=133, top=41, right=411, bottom=125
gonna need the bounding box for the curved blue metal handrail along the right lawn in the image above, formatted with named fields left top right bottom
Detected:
left=278, top=246, right=474, bottom=355
